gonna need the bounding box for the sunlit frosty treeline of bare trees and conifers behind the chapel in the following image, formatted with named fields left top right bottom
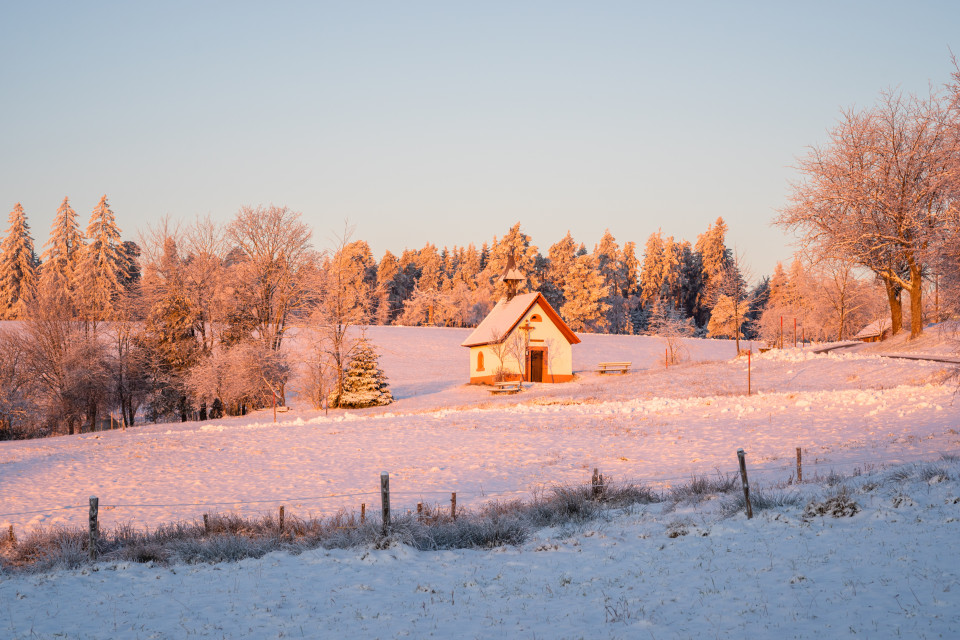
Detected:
left=0, top=197, right=900, bottom=437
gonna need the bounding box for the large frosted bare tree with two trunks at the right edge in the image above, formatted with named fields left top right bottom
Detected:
left=776, top=91, right=960, bottom=338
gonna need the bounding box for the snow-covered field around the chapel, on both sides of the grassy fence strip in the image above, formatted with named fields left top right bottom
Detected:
left=0, top=327, right=960, bottom=638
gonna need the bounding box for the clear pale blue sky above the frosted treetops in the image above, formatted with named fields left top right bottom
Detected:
left=0, top=0, right=960, bottom=276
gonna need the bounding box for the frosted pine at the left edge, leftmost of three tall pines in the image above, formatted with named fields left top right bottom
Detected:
left=0, top=202, right=38, bottom=320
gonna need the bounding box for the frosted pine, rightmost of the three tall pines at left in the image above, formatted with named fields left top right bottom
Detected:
left=76, top=196, right=125, bottom=323
